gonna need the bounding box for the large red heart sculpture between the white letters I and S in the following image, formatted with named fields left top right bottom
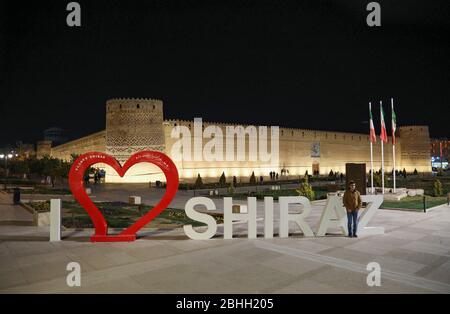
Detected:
left=69, top=151, right=179, bottom=242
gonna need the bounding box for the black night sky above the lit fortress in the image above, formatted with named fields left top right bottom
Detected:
left=0, top=0, right=450, bottom=145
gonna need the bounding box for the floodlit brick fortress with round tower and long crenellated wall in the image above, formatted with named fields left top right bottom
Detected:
left=37, top=99, right=431, bottom=182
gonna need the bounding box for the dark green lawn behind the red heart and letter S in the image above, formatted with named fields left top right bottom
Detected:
left=29, top=201, right=223, bottom=229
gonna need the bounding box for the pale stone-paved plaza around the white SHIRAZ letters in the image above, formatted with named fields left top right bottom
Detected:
left=0, top=185, right=450, bottom=293
